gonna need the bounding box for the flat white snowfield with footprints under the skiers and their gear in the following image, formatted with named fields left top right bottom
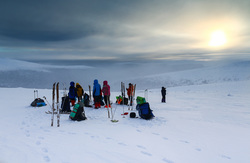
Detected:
left=0, top=80, right=250, bottom=163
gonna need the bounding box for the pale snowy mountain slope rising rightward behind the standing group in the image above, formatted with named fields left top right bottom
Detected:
left=120, top=61, right=250, bottom=89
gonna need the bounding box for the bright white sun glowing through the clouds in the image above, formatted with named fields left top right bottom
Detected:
left=209, top=30, right=227, bottom=46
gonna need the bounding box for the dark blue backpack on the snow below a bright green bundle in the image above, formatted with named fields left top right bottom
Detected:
left=136, top=102, right=154, bottom=120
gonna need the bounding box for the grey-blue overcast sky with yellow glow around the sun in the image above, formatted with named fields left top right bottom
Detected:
left=0, top=0, right=250, bottom=60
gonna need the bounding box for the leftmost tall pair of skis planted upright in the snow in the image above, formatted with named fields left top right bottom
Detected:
left=51, top=82, right=60, bottom=127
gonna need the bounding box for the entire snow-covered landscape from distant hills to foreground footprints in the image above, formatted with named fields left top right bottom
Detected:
left=0, top=59, right=250, bottom=163
